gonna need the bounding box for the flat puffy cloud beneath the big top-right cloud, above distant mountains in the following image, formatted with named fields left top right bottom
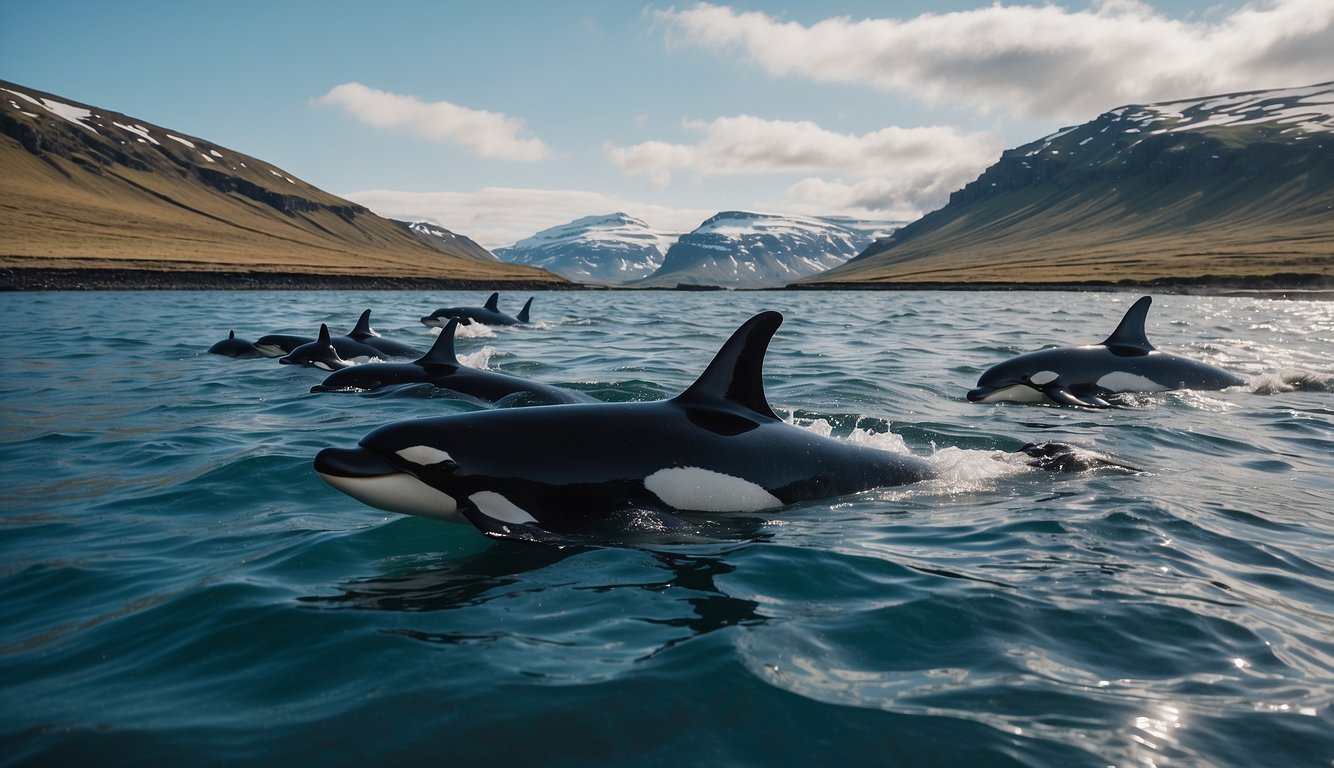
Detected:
left=607, top=115, right=1001, bottom=185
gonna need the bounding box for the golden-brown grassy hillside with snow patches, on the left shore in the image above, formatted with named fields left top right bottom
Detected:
left=0, top=81, right=564, bottom=284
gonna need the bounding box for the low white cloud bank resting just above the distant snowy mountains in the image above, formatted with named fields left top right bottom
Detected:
left=340, top=187, right=716, bottom=248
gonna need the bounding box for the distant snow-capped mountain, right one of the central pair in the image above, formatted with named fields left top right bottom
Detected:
left=635, top=211, right=895, bottom=288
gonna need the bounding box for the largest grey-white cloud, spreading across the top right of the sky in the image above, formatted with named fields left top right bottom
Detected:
left=656, top=0, right=1334, bottom=120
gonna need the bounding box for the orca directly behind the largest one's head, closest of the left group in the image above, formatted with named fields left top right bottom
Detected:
left=311, top=317, right=591, bottom=405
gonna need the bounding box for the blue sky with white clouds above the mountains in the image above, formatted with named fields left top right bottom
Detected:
left=0, top=0, right=1334, bottom=248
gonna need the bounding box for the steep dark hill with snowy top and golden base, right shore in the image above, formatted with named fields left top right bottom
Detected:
left=806, top=83, right=1334, bottom=287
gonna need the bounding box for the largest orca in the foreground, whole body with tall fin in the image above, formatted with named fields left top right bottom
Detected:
left=315, top=312, right=932, bottom=539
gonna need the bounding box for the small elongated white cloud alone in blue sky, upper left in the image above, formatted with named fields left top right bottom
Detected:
left=315, top=83, right=551, bottom=161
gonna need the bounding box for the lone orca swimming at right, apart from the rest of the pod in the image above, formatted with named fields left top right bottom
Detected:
left=968, top=296, right=1246, bottom=408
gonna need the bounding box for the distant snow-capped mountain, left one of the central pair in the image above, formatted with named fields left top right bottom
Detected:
left=496, top=213, right=676, bottom=284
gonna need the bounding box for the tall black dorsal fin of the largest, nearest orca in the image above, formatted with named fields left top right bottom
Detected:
left=676, top=312, right=783, bottom=419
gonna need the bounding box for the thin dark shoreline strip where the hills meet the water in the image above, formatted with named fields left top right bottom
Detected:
left=0, top=267, right=1334, bottom=301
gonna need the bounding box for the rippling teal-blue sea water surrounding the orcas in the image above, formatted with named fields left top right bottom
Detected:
left=0, top=292, right=1334, bottom=768
